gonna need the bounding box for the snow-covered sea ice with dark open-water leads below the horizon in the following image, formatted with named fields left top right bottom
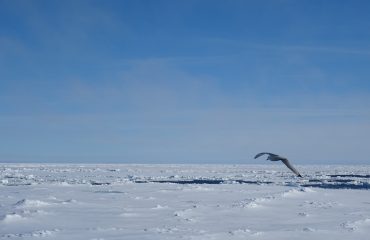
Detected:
left=0, top=164, right=370, bottom=240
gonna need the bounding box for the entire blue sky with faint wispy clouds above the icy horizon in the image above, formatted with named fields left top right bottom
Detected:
left=0, top=0, right=370, bottom=164
